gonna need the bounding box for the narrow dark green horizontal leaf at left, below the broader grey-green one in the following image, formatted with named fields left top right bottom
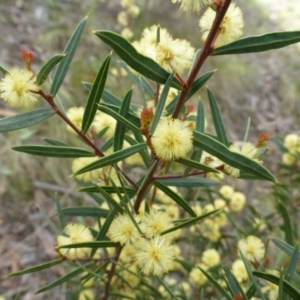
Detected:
left=12, top=145, right=95, bottom=158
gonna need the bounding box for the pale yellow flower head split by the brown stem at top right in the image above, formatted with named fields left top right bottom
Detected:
left=199, top=3, right=244, bottom=47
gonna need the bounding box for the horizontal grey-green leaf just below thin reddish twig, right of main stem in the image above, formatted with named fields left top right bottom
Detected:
left=156, top=178, right=220, bottom=188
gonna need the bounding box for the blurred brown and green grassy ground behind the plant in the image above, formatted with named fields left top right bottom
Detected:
left=0, top=0, right=300, bottom=299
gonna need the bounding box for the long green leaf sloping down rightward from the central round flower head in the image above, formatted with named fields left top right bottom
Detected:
left=194, top=131, right=276, bottom=181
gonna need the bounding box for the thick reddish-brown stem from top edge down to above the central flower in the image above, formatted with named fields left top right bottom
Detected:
left=172, top=0, right=231, bottom=119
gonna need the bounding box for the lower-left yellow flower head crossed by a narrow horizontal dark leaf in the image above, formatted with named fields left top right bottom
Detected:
left=57, top=223, right=93, bottom=260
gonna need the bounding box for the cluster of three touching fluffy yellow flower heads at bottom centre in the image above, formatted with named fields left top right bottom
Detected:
left=108, top=210, right=176, bottom=275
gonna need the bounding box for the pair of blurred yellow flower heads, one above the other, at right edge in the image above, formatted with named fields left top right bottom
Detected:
left=282, top=133, right=300, bottom=166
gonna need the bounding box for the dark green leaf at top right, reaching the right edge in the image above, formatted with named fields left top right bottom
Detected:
left=212, top=31, right=300, bottom=55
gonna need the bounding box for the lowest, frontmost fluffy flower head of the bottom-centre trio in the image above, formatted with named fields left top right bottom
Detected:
left=136, top=236, right=174, bottom=275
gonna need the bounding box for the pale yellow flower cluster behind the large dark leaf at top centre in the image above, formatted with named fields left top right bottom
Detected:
left=133, top=25, right=195, bottom=73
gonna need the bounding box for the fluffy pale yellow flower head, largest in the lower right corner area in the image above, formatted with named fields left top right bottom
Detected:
left=238, top=235, right=265, bottom=262
